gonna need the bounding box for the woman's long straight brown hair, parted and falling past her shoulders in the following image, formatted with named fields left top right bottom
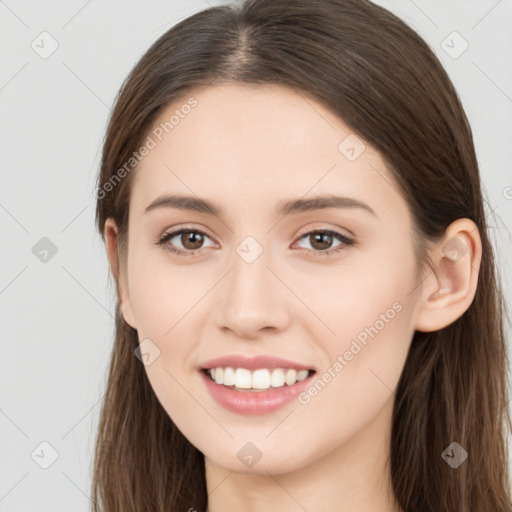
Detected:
left=92, top=0, right=512, bottom=512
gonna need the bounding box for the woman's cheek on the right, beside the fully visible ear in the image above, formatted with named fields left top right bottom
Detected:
left=298, top=246, right=416, bottom=410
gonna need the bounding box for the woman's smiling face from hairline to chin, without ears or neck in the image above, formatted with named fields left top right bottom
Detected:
left=113, top=84, right=419, bottom=474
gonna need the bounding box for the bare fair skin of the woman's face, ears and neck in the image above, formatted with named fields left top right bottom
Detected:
left=105, top=84, right=481, bottom=512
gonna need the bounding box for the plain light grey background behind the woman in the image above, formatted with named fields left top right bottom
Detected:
left=0, top=0, right=512, bottom=512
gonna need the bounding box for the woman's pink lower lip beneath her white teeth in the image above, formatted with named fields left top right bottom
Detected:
left=200, top=371, right=314, bottom=414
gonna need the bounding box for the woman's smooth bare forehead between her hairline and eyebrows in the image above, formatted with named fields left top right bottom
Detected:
left=128, top=83, right=404, bottom=220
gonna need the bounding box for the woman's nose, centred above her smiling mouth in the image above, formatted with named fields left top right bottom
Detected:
left=216, top=248, right=290, bottom=340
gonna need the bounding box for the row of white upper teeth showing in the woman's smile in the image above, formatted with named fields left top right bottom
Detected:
left=205, top=367, right=309, bottom=390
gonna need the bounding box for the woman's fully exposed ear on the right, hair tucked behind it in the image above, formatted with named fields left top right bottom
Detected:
left=415, top=219, right=482, bottom=332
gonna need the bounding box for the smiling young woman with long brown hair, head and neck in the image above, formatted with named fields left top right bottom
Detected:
left=93, top=0, right=512, bottom=512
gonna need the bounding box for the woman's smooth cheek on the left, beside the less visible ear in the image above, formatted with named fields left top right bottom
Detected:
left=129, top=248, right=206, bottom=400
